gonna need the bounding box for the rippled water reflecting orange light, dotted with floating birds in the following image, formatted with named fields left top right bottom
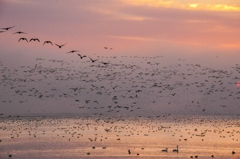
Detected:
left=0, top=115, right=240, bottom=159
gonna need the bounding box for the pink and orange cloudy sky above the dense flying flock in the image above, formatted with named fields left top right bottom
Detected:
left=0, top=0, right=240, bottom=117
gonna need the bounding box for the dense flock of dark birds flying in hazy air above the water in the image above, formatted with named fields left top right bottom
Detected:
left=0, top=26, right=240, bottom=115
